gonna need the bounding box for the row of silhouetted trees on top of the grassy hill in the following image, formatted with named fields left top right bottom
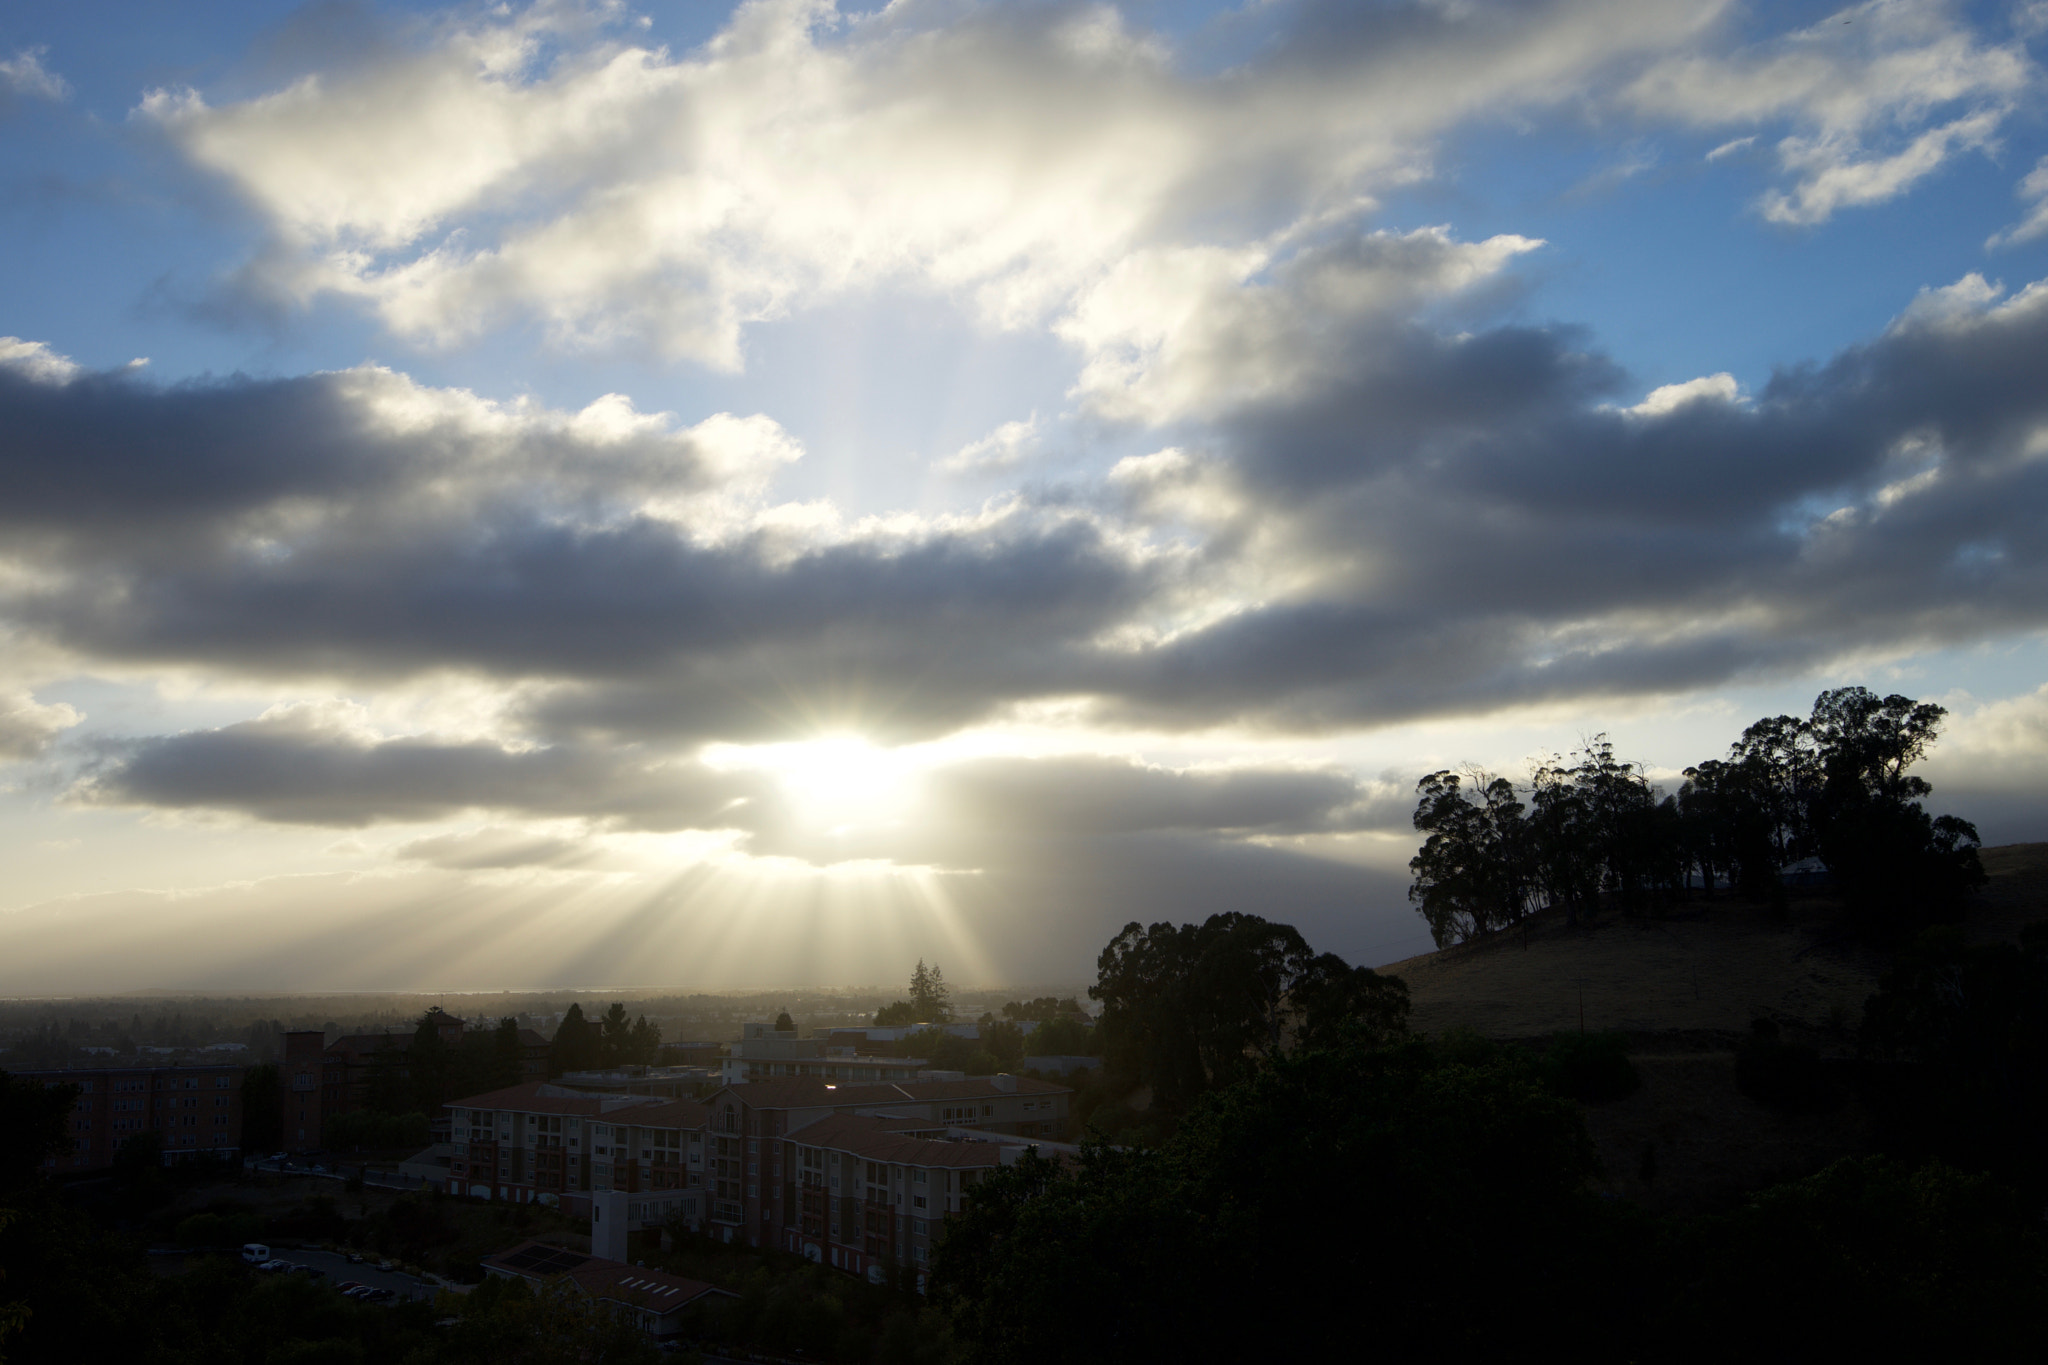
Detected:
left=1409, top=688, right=1985, bottom=948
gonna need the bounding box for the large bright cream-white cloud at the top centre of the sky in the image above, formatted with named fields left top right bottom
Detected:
left=139, top=0, right=1716, bottom=368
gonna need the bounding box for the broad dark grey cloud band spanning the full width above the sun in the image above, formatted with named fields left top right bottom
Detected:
left=12, top=270, right=2048, bottom=757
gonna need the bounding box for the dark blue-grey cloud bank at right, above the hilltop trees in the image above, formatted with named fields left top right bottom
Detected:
left=1094, top=291, right=2048, bottom=729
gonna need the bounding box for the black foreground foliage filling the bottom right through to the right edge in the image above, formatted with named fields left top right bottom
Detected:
left=934, top=1036, right=2048, bottom=1365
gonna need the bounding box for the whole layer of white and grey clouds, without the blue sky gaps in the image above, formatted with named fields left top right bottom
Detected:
left=0, top=0, right=2048, bottom=994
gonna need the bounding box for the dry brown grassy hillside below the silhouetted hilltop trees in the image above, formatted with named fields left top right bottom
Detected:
left=1384, top=843, right=2048, bottom=1212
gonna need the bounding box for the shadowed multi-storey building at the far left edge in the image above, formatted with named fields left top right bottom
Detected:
left=16, top=1064, right=246, bottom=1171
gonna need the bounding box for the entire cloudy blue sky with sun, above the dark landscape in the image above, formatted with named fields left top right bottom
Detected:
left=0, top=0, right=2048, bottom=995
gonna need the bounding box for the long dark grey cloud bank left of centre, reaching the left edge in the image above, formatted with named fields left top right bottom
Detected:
left=0, top=356, right=1149, bottom=739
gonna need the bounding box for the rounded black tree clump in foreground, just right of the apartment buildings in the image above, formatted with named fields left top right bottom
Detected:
left=934, top=1042, right=1624, bottom=1363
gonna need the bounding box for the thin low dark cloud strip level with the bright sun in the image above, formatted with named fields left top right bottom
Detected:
left=74, top=706, right=1407, bottom=868
